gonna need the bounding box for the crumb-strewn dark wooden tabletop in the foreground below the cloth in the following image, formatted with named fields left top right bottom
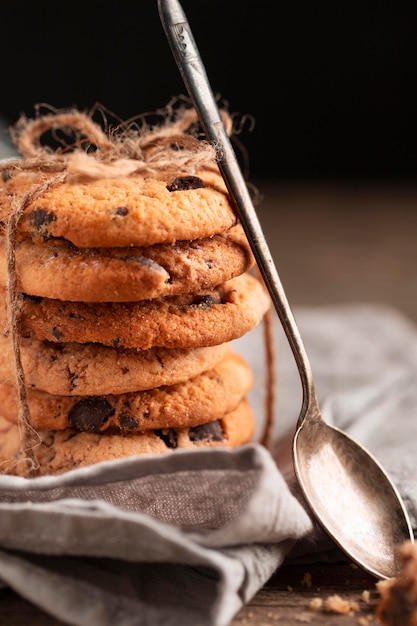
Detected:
left=0, top=563, right=380, bottom=626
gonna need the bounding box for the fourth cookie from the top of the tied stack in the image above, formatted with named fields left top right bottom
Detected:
left=0, top=335, right=230, bottom=395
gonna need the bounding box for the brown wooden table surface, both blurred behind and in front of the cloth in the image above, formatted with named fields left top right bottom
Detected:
left=0, top=181, right=417, bottom=626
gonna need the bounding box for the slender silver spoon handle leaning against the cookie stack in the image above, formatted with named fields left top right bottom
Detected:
left=158, top=0, right=316, bottom=414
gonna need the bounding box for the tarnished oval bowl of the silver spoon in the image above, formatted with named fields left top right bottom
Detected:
left=293, top=404, right=413, bottom=579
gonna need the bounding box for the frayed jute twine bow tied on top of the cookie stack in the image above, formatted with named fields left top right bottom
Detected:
left=4, top=108, right=218, bottom=180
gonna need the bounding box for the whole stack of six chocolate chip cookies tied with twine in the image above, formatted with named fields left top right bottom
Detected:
left=0, top=109, right=270, bottom=475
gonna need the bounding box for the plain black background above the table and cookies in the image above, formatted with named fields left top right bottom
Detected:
left=0, top=0, right=417, bottom=181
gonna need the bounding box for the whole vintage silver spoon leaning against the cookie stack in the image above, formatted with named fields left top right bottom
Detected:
left=158, top=0, right=413, bottom=578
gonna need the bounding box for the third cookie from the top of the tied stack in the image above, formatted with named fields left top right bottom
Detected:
left=12, top=274, right=270, bottom=350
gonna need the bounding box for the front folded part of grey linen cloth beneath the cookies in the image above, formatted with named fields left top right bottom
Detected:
left=0, top=444, right=311, bottom=626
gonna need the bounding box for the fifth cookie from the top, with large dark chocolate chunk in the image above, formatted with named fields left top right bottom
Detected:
left=0, top=353, right=253, bottom=433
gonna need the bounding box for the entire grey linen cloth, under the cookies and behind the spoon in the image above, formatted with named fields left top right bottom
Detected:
left=0, top=305, right=417, bottom=626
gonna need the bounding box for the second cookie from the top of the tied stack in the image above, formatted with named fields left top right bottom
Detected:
left=0, top=225, right=254, bottom=302
